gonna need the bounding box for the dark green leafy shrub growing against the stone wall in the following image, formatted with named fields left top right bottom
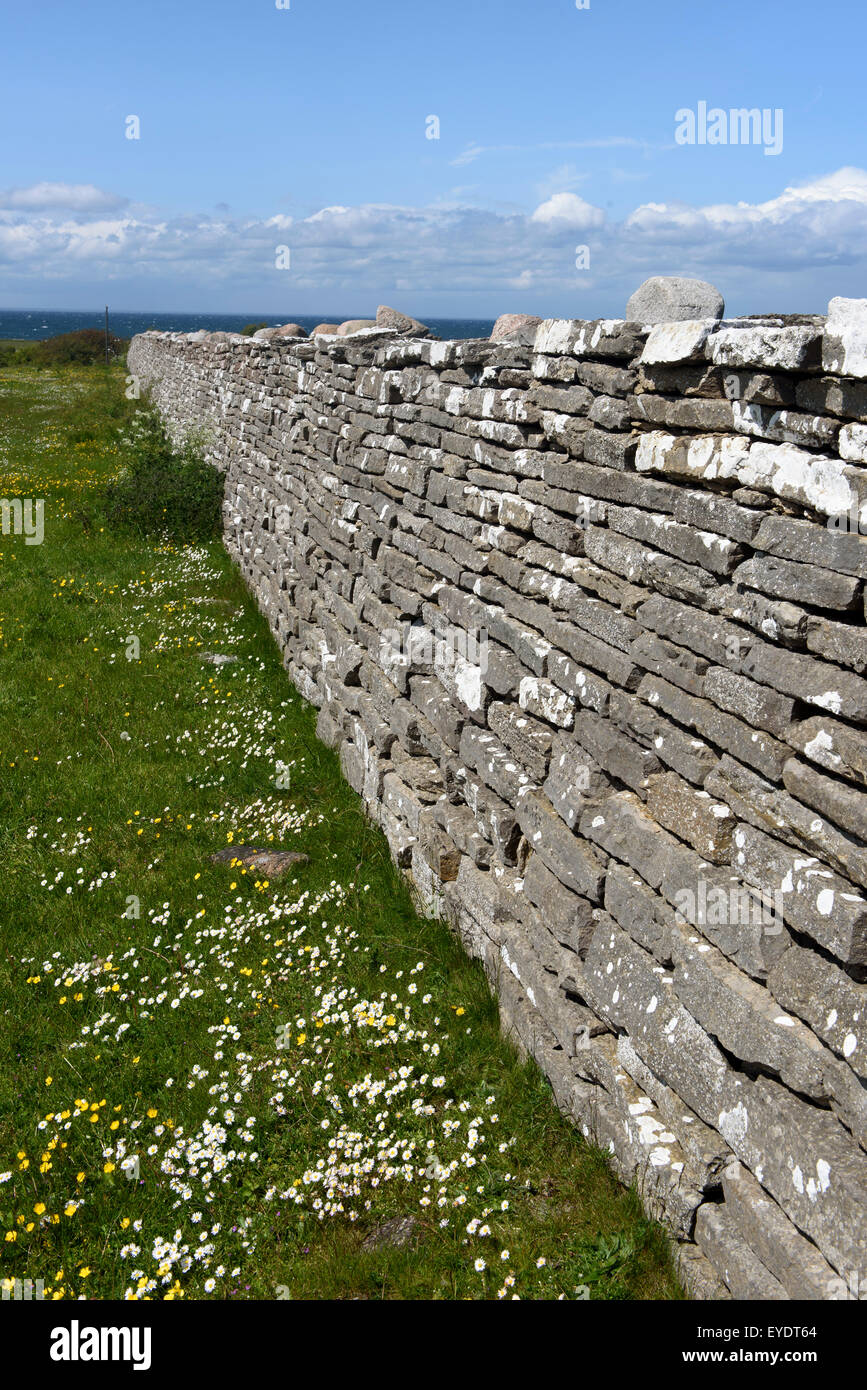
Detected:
left=104, top=407, right=222, bottom=541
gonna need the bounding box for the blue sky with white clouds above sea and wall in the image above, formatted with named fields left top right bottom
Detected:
left=0, top=0, right=867, bottom=318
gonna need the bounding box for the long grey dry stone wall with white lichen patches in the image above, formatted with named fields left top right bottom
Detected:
left=129, top=300, right=867, bottom=1300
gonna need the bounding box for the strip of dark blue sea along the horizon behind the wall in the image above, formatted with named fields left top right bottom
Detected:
left=0, top=309, right=493, bottom=339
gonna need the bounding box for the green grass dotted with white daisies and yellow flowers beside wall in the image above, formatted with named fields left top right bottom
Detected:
left=0, top=367, right=682, bottom=1300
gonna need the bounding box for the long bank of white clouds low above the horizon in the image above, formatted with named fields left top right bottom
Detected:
left=0, top=168, right=867, bottom=316
